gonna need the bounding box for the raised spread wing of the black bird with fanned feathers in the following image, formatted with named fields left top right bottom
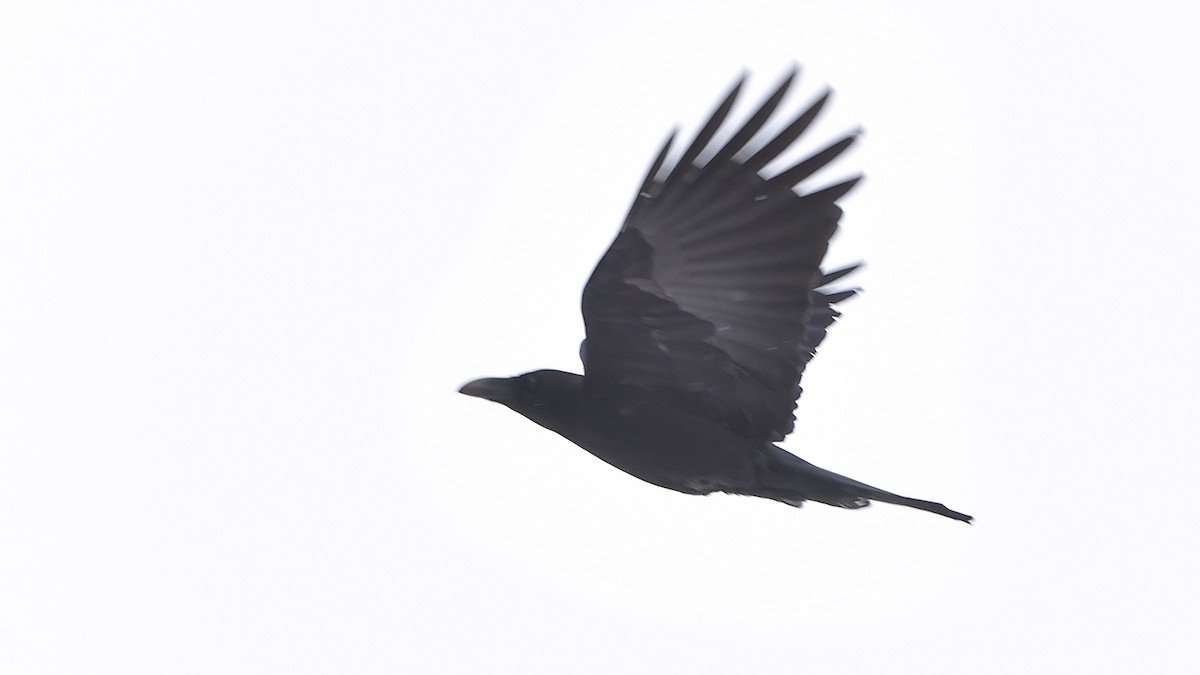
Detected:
left=581, top=70, right=858, bottom=441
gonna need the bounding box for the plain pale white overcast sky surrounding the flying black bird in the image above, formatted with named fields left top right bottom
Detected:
left=0, top=0, right=1200, bottom=675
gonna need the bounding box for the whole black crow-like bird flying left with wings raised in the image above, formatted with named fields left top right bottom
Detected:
left=461, top=68, right=971, bottom=522
